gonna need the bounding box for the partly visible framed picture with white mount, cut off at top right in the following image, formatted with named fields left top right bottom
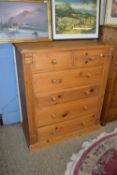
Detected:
left=105, top=0, right=117, bottom=26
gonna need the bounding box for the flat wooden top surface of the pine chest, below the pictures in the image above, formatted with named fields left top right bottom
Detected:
left=15, top=40, right=109, bottom=53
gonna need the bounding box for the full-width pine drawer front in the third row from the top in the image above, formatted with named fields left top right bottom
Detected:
left=34, top=85, right=100, bottom=108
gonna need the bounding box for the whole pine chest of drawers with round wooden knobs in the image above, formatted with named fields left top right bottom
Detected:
left=15, top=41, right=112, bottom=150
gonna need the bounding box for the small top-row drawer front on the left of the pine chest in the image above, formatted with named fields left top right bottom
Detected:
left=32, top=51, right=73, bottom=71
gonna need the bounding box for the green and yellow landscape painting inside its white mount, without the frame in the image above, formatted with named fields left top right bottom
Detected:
left=55, top=0, right=98, bottom=35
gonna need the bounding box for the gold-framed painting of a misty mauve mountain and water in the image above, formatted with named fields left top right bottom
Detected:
left=0, top=0, right=51, bottom=43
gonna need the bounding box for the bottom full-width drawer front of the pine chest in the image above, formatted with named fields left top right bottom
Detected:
left=38, top=114, right=99, bottom=141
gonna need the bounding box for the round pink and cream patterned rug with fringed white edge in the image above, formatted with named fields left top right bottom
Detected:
left=65, top=129, right=117, bottom=175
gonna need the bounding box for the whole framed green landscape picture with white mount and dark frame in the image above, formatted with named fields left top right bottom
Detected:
left=52, top=0, right=100, bottom=40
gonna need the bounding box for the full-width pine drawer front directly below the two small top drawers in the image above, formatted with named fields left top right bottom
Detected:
left=32, top=66, right=103, bottom=93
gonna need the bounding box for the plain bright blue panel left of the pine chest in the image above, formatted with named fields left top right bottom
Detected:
left=0, top=44, right=20, bottom=124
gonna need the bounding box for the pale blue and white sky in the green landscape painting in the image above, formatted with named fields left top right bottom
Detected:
left=55, top=0, right=94, bottom=10
